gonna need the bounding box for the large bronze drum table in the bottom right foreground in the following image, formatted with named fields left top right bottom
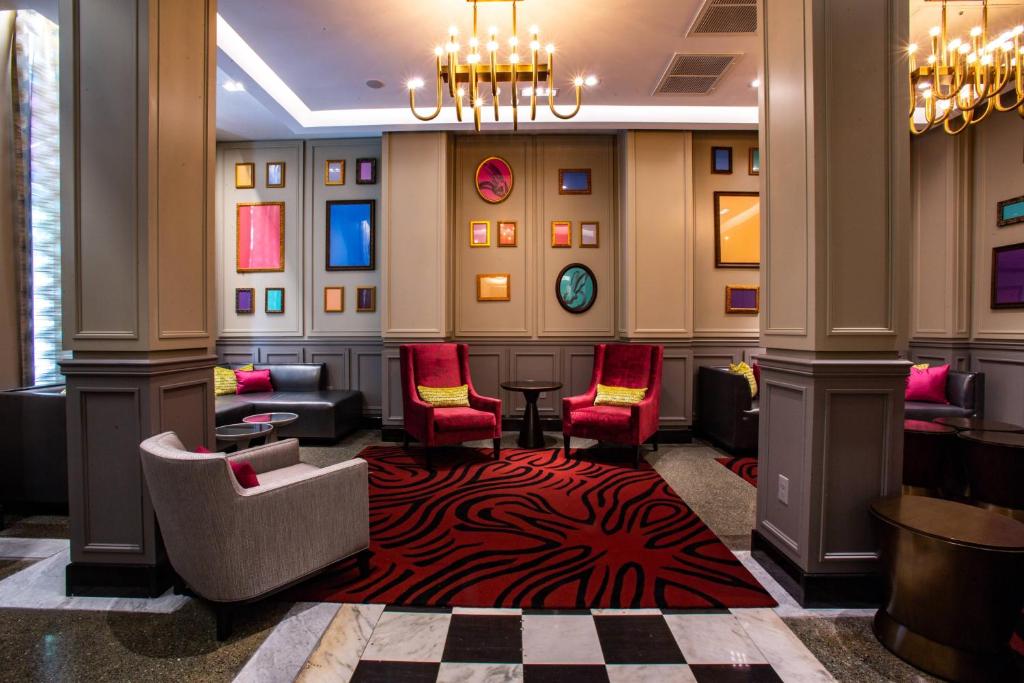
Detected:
left=871, top=496, right=1024, bottom=681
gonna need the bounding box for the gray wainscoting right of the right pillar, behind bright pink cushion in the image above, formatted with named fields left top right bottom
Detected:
left=909, top=339, right=1024, bottom=425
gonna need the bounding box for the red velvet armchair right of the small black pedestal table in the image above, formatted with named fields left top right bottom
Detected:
left=562, top=344, right=665, bottom=467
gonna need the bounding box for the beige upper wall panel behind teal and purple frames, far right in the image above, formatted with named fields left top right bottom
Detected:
left=972, top=114, right=1024, bottom=340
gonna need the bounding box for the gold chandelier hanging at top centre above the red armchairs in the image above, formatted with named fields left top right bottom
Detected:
left=407, top=0, right=597, bottom=131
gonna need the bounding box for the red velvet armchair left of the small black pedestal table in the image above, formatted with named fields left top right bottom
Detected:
left=399, top=344, right=502, bottom=458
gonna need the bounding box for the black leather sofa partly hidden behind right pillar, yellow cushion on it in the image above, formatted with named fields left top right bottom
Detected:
left=696, top=367, right=760, bottom=454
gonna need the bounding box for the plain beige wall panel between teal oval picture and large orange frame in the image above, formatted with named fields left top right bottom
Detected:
left=624, top=131, right=693, bottom=337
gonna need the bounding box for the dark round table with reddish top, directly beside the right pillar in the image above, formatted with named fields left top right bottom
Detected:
left=903, top=420, right=956, bottom=496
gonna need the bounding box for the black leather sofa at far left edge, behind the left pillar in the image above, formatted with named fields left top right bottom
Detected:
left=0, top=384, right=68, bottom=514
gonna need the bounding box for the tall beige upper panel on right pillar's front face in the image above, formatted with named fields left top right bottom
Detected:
left=816, top=2, right=892, bottom=335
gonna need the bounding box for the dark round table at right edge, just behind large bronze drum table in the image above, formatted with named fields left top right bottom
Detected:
left=958, top=431, right=1024, bottom=521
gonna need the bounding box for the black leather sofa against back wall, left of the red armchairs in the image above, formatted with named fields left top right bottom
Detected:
left=216, top=362, right=362, bottom=439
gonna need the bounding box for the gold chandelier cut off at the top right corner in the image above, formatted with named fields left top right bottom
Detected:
left=907, top=0, right=1024, bottom=135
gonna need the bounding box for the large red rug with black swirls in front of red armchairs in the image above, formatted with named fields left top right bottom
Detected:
left=288, top=446, right=775, bottom=609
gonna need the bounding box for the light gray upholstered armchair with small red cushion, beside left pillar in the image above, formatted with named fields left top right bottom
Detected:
left=139, top=432, right=370, bottom=640
